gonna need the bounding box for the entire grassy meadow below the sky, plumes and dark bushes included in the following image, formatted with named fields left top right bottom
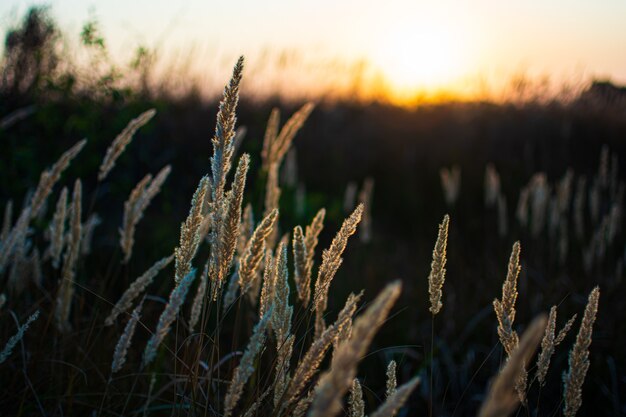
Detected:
left=0, top=9, right=626, bottom=417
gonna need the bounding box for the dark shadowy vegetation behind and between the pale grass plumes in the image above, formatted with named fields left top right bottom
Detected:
left=0, top=9, right=626, bottom=416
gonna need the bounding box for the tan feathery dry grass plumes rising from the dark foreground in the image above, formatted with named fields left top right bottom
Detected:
left=0, top=58, right=604, bottom=417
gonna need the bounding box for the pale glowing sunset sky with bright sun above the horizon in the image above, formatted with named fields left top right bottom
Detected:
left=0, top=0, right=626, bottom=102
